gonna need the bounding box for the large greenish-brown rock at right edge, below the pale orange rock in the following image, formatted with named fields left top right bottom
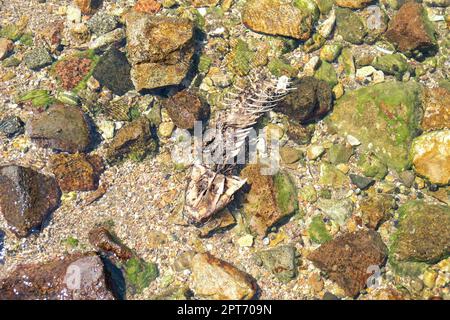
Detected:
left=389, top=200, right=450, bottom=275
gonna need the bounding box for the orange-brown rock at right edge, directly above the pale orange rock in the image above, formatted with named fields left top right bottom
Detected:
left=421, top=87, right=450, bottom=131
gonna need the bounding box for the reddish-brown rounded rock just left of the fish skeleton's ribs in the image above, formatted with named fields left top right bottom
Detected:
left=164, top=90, right=210, bottom=129
